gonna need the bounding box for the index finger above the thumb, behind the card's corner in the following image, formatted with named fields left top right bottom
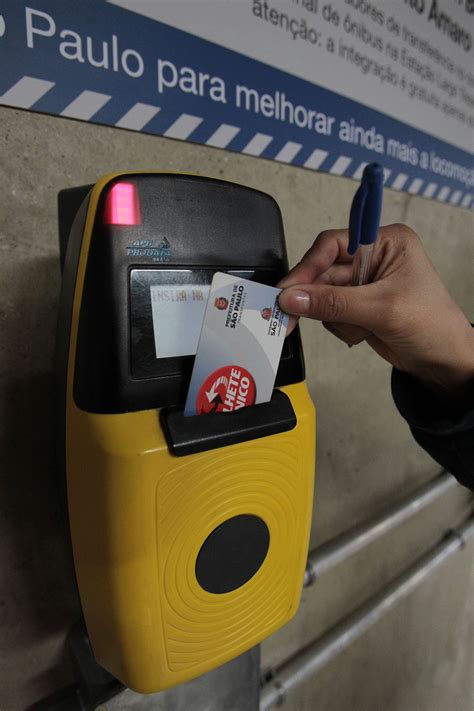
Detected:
left=278, top=230, right=353, bottom=288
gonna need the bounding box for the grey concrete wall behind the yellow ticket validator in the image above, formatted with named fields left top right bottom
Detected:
left=0, top=109, right=474, bottom=711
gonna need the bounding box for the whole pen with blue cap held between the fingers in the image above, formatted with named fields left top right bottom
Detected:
left=347, top=163, right=384, bottom=286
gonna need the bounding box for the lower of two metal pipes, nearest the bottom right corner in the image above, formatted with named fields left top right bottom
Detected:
left=260, top=515, right=474, bottom=711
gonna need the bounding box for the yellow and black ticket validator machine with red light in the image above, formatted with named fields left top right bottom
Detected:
left=58, top=173, right=315, bottom=693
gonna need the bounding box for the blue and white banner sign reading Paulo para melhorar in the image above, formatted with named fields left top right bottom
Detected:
left=0, top=0, right=474, bottom=208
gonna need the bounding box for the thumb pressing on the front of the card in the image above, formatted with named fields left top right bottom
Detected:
left=279, top=283, right=381, bottom=331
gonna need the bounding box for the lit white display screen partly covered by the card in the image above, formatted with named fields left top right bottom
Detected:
left=150, top=284, right=210, bottom=358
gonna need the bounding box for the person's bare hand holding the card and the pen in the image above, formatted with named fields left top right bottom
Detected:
left=279, top=225, right=474, bottom=394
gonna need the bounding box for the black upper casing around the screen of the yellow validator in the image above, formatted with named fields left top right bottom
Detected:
left=59, top=173, right=304, bottom=413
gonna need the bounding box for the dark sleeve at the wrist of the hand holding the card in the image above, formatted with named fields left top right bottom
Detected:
left=392, top=368, right=474, bottom=491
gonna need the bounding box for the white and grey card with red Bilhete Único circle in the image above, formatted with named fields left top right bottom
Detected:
left=184, top=272, right=288, bottom=415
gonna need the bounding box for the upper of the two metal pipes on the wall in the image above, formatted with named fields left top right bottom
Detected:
left=303, top=472, right=458, bottom=587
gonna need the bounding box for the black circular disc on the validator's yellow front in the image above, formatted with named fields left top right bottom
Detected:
left=196, top=514, right=270, bottom=594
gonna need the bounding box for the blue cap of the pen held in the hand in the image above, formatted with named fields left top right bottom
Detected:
left=347, top=163, right=384, bottom=256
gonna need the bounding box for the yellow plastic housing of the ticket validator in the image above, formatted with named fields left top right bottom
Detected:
left=66, top=176, right=315, bottom=693
